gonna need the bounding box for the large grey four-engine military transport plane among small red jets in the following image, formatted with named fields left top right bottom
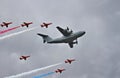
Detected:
left=37, top=26, right=85, bottom=48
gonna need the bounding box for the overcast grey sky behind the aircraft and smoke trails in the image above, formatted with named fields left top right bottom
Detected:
left=0, top=0, right=120, bottom=78
